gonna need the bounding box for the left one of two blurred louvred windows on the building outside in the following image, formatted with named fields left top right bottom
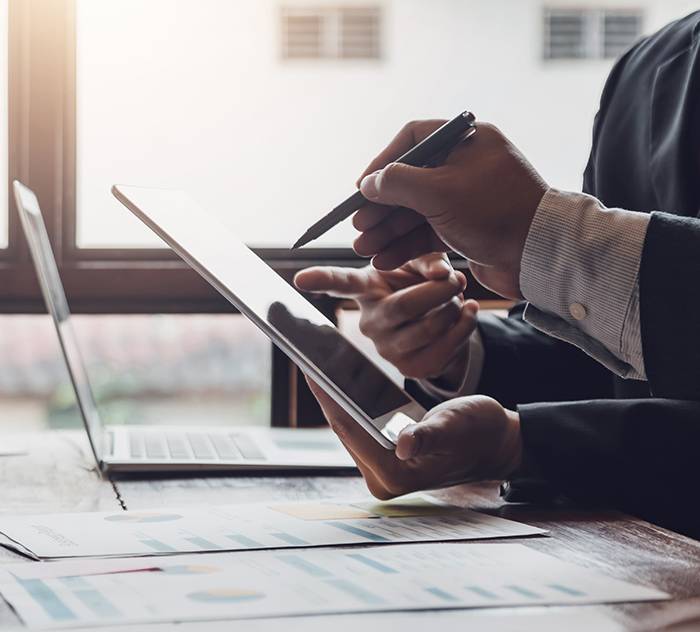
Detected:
left=282, top=7, right=381, bottom=59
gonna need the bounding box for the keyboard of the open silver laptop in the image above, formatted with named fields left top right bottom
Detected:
left=129, top=430, right=265, bottom=461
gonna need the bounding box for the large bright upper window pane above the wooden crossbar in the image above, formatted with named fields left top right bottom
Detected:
left=77, top=0, right=694, bottom=247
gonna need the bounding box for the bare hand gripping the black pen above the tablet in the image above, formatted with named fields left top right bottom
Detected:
left=353, top=121, right=547, bottom=299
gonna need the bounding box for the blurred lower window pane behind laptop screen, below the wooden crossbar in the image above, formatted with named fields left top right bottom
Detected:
left=0, top=315, right=271, bottom=432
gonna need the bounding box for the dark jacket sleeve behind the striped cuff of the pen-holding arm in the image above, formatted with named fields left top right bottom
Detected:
left=639, top=213, right=700, bottom=400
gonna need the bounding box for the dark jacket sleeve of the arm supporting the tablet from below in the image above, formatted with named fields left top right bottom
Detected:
left=518, top=399, right=700, bottom=537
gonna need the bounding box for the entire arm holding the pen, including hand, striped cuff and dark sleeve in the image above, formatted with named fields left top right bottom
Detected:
left=354, top=122, right=700, bottom=397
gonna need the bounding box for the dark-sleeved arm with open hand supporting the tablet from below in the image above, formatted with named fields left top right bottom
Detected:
left=311, top=372, right=700, bottom=536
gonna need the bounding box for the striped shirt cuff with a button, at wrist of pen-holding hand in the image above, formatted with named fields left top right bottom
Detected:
left=520, top=189, right=649, bottom=379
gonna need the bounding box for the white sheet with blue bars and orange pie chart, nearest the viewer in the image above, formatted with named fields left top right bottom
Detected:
left=0, top=543, right=667, bottom=628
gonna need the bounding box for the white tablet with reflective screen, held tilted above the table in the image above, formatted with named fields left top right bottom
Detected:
left=112, top=185, right=425, bottom=449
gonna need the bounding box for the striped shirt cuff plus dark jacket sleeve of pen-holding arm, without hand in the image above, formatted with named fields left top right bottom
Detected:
left=520, top=192, right=700, bottom=400
